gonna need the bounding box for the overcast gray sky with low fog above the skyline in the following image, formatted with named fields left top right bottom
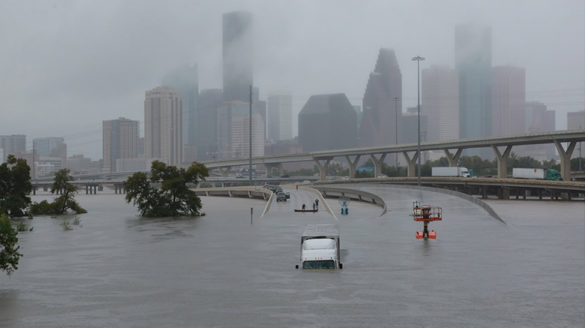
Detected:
left=0, top=0, right=585, bottom=159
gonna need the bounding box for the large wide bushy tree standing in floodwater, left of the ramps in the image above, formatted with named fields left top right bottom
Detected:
left=124, top=161, right=209, bottom=217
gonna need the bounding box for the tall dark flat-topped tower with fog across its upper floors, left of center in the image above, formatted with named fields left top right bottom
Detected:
left=223, top=11, right=254, bottom=102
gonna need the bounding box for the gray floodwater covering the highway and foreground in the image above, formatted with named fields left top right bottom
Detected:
left=0, top=186, right=585, bottom=327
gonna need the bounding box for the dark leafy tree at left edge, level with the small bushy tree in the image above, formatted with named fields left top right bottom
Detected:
left=0, top=155, right=32, bottom=216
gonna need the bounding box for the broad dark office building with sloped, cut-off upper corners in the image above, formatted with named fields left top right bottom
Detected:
left=299, top=93, right=357, bottom=152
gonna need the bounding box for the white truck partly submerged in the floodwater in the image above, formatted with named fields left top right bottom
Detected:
left=296, top=224, right=343, bottom=270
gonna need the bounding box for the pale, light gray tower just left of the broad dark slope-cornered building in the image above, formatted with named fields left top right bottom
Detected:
left=268, top=94, right=292, bottom=141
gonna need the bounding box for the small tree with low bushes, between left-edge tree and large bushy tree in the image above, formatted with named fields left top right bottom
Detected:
left=31, top=169, right=87, bottom=215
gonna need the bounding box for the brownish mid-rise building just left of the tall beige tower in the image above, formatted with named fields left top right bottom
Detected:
left=103, top=117, right=139, bottom=172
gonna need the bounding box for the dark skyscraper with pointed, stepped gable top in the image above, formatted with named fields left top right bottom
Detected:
left=359, top=48, right=402, bottom=146
